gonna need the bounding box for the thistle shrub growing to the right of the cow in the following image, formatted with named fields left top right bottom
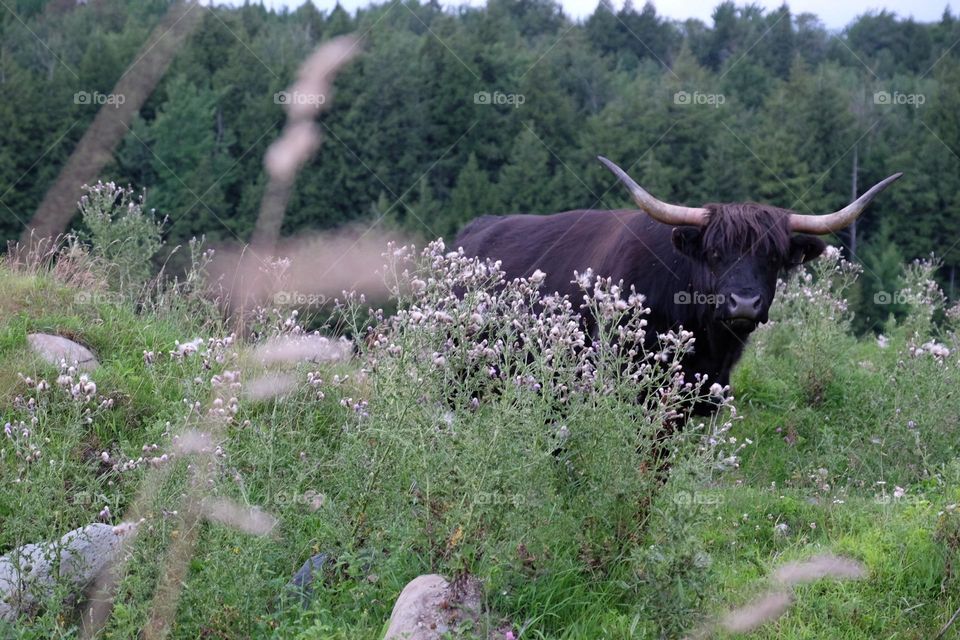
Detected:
left=736, top=250, right=960, bottom=490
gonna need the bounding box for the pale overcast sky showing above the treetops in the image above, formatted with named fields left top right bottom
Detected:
left=228, top=0, right=947, bottom=29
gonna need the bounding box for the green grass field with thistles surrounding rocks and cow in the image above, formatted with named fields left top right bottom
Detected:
left=0, top=231, right=960, bottom=640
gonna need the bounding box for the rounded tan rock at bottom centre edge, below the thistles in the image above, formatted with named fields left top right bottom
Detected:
left=384, top=574, right=483, bottom=640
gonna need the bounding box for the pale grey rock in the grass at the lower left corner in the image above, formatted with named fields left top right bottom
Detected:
left=0, top=523, right=136, bottom=620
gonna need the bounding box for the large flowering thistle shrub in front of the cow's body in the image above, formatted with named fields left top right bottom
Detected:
left=320, top=241, right=736, bottom=620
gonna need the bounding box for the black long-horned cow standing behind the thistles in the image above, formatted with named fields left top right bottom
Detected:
left=455, top=157, right=902, bottom=413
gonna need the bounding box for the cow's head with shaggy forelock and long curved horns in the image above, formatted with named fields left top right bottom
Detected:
left=600, top=156, right=903, bottom=334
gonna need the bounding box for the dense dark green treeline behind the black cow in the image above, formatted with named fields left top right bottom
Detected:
left=0, top=0, right=960, bottom=328
